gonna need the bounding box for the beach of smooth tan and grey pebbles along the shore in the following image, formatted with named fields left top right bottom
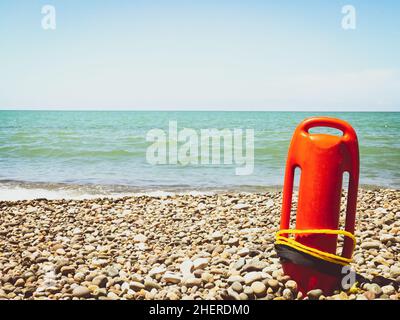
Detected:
left=0, top=189, right=400, bottom=300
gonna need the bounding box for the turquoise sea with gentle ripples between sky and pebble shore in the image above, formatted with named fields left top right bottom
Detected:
left=0, top=111, right=400, bottom=198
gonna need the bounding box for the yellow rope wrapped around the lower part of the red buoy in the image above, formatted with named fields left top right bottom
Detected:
left=275, top=229, right=356, bottom=266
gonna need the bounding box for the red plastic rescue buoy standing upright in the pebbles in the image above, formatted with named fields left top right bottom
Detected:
left=277, top=117, right=359, bottom=294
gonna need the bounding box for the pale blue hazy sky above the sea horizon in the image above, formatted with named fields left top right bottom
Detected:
left=0, top=0, right=400, bottom=111
